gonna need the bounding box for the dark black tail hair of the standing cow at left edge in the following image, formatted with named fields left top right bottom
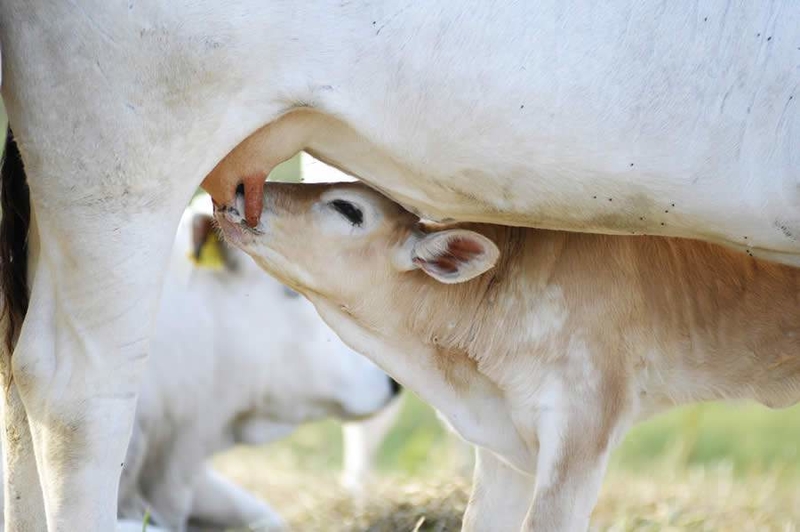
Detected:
left=0, top=128, right=31, bottom=357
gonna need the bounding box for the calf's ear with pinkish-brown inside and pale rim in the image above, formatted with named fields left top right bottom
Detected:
left=411, top=229, right=500, bottom=284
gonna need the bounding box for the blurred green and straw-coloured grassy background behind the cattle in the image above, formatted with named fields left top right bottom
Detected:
left=0, top=104, right=800, bottom=531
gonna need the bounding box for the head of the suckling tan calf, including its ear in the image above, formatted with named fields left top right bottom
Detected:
left=215, top=183, right=500, bottom=306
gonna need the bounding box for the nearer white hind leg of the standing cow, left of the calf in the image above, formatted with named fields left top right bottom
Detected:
left=10, top=201, right=181, bottom=531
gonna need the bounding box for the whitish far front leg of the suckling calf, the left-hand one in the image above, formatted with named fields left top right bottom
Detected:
left=462, top=447, right=534, bottom=532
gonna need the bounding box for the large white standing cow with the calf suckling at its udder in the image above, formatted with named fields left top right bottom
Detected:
left=0, top=0, right=800, bottom=531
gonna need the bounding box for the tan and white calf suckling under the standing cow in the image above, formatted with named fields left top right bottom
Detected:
left=216, top=183, right=800, bottom=531
